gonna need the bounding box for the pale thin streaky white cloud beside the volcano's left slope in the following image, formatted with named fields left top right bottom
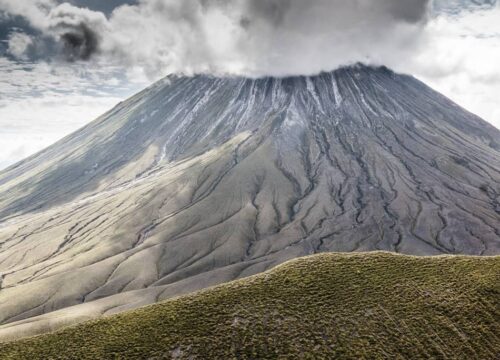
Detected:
left=0, top=58, right=145, bottom=169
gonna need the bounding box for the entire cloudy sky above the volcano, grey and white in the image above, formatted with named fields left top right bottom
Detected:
left=0, top=0, right=500, bottom=169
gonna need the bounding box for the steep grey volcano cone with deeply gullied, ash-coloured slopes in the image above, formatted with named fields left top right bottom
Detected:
left=0, top=66, right=500, bottom=336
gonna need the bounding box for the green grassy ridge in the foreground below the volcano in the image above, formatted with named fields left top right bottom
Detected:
left=0, top=253, right=500, bottom=360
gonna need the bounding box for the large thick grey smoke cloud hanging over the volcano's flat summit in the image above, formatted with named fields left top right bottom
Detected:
left=0, top=0, right=430, bottom=76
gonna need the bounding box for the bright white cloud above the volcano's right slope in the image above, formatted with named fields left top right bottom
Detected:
left=402, top=5, right=500, bottom=128
